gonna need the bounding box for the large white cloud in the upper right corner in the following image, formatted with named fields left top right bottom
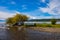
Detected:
left=39, top=0, right=60, bottom=15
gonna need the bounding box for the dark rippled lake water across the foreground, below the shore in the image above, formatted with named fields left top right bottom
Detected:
left=0, top=22, right=60, bottom=40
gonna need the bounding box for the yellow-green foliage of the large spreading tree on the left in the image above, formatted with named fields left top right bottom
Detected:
left=6, top=14, right=28, bottom=25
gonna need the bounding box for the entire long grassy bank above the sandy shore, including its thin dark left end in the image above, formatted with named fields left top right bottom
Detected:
left=24, top=23, right=60, bottom=28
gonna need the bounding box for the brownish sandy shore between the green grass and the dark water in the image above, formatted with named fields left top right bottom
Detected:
left=29, top=27, right=60, bottom=33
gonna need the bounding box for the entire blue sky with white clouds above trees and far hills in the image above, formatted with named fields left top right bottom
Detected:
left=0, top=0, right=60, bottom=20
